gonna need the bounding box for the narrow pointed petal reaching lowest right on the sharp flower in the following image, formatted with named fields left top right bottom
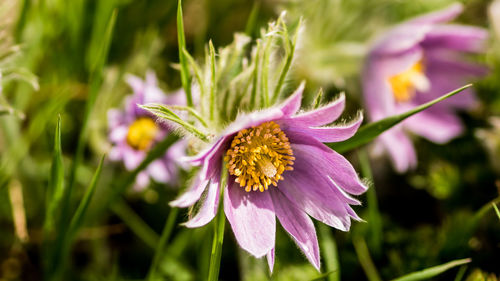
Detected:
left=269, top=188, right=320, bottom=270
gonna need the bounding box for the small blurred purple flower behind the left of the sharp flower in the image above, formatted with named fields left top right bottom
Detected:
left=108, top=71, right=185, bottom=190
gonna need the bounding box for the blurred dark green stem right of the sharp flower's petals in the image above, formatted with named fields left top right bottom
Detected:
left=358, top=149, right=382, bottom=255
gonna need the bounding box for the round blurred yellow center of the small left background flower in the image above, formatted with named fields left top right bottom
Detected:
left=127, top=117, right=159, bottom=150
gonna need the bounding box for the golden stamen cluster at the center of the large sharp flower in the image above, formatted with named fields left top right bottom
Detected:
left=224, top=121, right=295, bottom=192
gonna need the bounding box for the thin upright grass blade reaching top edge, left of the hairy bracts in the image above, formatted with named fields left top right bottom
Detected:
left=177, top=0, right=193, bottom=106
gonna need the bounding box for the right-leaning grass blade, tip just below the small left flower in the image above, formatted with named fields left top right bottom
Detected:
left=68, top=155, right=105, bottom=238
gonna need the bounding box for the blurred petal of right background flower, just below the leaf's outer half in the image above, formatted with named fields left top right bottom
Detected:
left=403, top=110, right=463, bottom=144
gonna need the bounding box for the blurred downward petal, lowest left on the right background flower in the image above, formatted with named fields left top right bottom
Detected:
left=379, top=127, right=417, bottom=173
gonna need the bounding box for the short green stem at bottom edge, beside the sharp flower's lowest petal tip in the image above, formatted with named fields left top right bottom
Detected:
left=318, top=224, right=340, bottom=281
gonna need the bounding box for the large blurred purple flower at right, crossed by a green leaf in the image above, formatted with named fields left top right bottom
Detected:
left=363, top=4, right=488, bottom=172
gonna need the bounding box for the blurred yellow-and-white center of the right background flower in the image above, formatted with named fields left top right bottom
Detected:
left=389, top=61, right=430, bottom=102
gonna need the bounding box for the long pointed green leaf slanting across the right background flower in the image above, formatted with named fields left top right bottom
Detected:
left=328, top=84, right=472, bottom=153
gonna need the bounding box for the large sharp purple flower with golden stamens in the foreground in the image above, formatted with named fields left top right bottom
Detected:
left=171, top=84, right=367, bottom=270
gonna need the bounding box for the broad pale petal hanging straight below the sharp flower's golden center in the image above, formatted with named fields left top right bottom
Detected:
left=224, top=177, right=276, bottom=258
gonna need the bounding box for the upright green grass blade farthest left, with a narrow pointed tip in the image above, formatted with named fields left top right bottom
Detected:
left=43, top=116, right=64, bottom=235
